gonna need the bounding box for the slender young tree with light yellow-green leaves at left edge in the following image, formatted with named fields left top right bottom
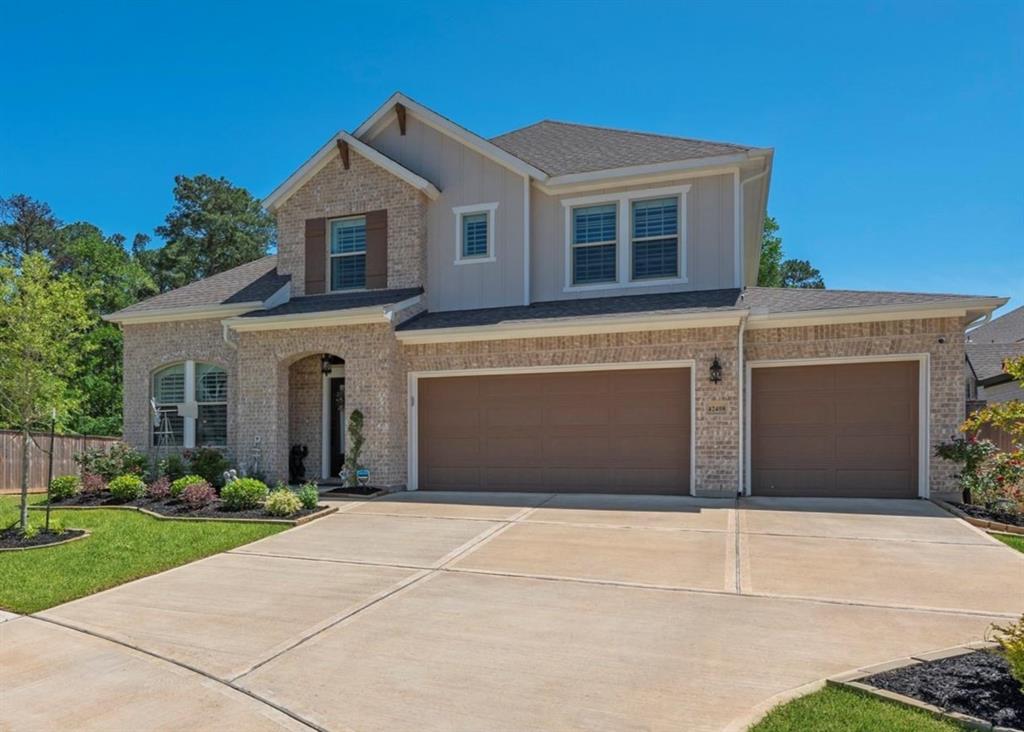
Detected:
left=0, top=254, right=90, bottom=530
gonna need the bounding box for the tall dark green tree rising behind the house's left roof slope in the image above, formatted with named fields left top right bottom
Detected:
left=141, top=175, right=274, bottom=292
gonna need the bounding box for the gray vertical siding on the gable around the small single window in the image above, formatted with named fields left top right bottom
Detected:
left=369, top=116, right=524, bottom=310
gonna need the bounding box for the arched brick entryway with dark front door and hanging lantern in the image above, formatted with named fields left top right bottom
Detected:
left=286, top=353, right=345, bottom=483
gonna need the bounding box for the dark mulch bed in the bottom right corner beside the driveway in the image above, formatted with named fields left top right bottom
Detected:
left=862, top=651, right=1024, bottom=729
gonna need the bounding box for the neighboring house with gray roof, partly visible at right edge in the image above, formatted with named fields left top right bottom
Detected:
left=967, top=307, right=1024, bottom=402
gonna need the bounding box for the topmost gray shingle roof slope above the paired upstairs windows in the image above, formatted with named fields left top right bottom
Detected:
left=490, top=120, right=755, bottom=176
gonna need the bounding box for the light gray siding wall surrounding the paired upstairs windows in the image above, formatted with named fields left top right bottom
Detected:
left=529, top=173, right=736, bottom=302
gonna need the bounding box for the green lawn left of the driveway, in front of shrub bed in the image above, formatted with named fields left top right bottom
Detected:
left=0, top=497, right=287, bottom=613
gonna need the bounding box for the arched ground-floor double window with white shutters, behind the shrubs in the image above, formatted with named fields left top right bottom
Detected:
left=153, top=360, right=227, bottom=447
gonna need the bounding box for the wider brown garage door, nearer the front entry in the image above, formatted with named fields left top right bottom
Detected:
left=418, top=369, right=690, bottom=493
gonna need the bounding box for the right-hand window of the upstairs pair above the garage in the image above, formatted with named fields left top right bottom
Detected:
left=630, top=196, right=679, bottom=279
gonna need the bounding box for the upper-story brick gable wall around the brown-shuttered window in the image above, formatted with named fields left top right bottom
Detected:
left=278, top=150, right=427, bottom=296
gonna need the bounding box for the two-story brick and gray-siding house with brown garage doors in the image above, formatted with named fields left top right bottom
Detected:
left=110, top=94, right=1006, bottom=497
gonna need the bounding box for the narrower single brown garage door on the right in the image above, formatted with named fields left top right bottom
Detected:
left=751, top=361, right=919, bottom=499
